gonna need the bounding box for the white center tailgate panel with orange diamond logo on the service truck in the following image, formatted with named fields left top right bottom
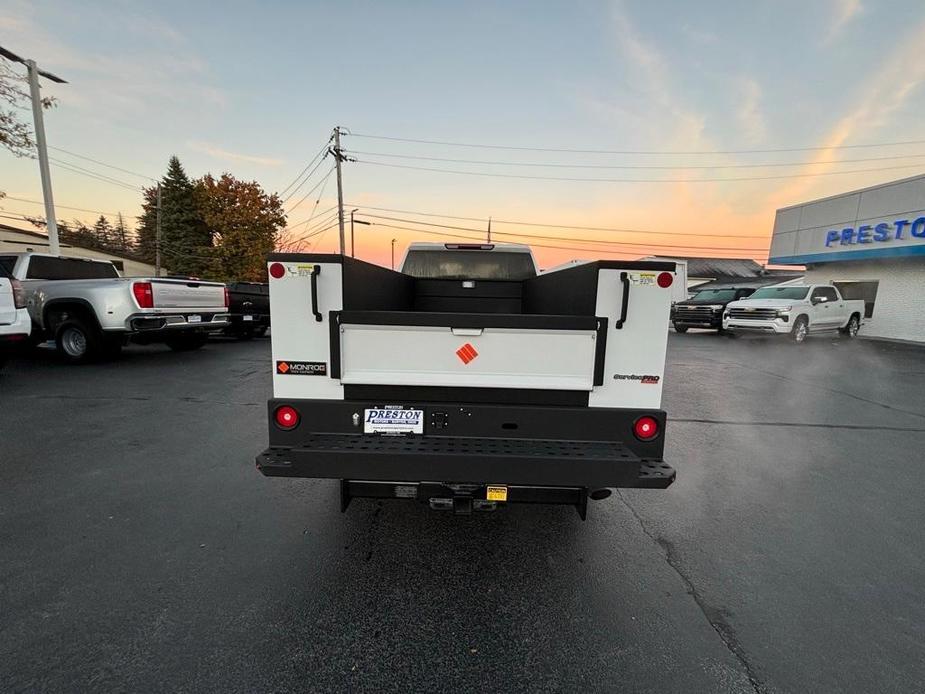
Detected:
left=332, top=311, right=607, bottom=391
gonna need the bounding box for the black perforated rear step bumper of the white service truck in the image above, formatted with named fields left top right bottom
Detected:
left=257, top=433, right=675, bottom=489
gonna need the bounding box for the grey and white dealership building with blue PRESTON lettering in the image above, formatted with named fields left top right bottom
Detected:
left=769, top=175, right=925, bottom=343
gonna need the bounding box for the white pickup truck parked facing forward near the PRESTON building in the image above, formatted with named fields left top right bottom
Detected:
left=723, top=284, right=864, bottom=342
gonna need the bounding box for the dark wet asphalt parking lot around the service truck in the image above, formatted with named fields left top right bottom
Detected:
left=0, top=332, right=925, bottom=692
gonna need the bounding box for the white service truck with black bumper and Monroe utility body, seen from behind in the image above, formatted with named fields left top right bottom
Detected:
left=257, top=243, right=675, bottom=518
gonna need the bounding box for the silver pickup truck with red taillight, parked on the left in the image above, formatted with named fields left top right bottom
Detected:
left=0, top=253, right=229, bottom=363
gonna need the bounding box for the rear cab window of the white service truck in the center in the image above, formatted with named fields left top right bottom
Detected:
left=402, top=250, right=536, bottom=280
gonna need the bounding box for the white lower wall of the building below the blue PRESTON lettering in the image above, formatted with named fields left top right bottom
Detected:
left=805, top=258, right=925, bottom=342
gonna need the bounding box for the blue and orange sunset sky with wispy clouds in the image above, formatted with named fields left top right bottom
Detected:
left=0, top=0, right=925, bottom=266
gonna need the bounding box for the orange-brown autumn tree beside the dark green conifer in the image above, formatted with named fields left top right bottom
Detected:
left=195, top=173, right=286, bottom=282
